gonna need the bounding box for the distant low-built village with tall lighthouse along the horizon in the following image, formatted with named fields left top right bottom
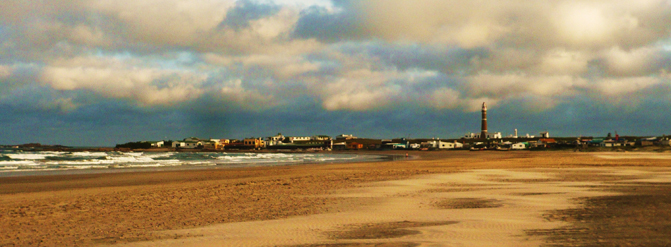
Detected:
left=111, top=102, right=671, bottom=151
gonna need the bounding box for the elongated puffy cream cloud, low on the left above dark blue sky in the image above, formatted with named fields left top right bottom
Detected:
left=42, top=58, right=207, bottom=105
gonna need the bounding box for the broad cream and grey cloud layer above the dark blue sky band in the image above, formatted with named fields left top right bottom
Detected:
left=0, top=0, right=671, bottom=121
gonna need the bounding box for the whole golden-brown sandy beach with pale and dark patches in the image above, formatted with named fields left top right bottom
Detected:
left=0, top=151, right=671, bottom=246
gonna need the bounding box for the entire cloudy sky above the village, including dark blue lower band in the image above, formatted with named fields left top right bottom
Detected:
left=0, top=0, right=671, bottom=146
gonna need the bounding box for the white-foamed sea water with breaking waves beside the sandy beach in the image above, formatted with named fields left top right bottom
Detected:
left=0, top=150, right=388, bottom=177
